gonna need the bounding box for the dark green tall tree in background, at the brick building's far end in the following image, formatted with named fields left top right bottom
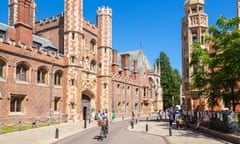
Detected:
left=156, top=52, right=181, bottom=109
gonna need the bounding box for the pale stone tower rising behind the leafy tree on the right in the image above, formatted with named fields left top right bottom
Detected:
left=182, top=0, right=208, bottom=110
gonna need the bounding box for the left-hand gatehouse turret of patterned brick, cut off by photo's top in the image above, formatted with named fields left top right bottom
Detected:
left=64, top=0, right=84, bottom=120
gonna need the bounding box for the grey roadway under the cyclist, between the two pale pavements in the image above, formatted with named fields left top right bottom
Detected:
left=56, top=121, right=167, bottom=144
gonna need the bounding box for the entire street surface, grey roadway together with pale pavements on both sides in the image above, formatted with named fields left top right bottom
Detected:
left=0, top=119, right=236, bottom=144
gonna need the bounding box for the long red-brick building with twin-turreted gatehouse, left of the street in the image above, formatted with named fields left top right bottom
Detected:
left=0, top=0, right=163, bottom=125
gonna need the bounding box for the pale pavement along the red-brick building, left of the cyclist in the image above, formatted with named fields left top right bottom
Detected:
left=0, top=121, right=97, bottom=144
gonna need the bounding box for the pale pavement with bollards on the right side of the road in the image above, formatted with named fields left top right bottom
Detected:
left=128, top=121, right=232, bottom=144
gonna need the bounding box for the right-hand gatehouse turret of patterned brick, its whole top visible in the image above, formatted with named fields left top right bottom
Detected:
left=97, top=7, right=112, bottom=115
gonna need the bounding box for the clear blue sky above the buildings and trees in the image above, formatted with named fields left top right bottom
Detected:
left=0, top=0, right=237, bottom=72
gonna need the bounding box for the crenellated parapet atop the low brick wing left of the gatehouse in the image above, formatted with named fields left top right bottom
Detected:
left=0, top=36, right=63, bottom=59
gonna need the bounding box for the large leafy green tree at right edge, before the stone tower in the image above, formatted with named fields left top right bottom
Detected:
left=191, top=16, right=240, bottom=111
